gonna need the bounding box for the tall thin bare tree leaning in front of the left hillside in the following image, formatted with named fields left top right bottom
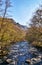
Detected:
left=0, top=0, right=11, bottom=41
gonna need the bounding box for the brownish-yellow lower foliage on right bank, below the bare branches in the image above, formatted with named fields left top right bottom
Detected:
left=26, top=27, right=42, bottom=47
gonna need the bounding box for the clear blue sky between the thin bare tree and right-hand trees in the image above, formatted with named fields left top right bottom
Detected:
left=11, top=0, right=42, bottom=26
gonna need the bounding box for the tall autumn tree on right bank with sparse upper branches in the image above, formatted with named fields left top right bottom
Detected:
left=26, top=6, right=42, bottom=47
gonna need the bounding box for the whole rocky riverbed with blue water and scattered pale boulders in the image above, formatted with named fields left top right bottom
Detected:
left=0, top=42, right=42, bottom=65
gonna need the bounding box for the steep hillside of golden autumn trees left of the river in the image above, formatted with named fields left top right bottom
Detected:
left=0, top=18, right=25, bottom=43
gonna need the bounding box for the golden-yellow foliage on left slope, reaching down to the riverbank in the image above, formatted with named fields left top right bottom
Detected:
left=0, top=18, right=25, bottom=55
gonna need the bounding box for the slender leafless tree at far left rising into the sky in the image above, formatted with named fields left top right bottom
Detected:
left=0, top=0, right=11, bottom=41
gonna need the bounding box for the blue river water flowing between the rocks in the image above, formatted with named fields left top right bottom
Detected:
left=0, top=42, right=42, bottom=65
